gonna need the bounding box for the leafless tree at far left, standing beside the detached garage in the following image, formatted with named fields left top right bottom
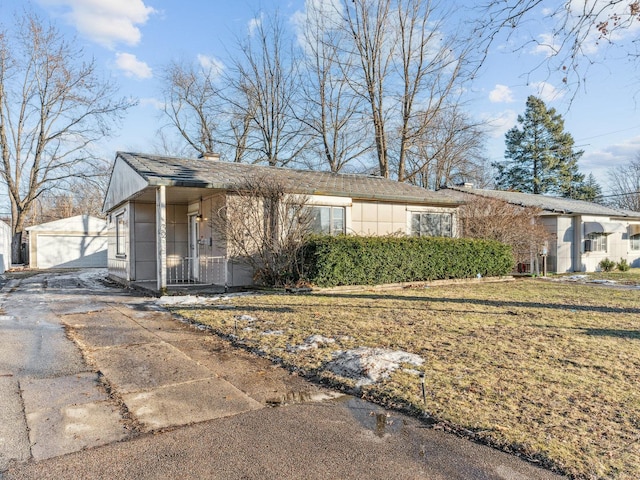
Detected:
left=0, top=12, right=132, bottom=263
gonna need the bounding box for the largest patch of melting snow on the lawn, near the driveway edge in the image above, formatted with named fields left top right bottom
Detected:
left=327, top=347, right=424, bottom=386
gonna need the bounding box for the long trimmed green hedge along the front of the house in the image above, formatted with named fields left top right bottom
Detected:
left=303, top=235, right=514, bottom=287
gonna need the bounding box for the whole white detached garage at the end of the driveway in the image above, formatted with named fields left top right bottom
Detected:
left=27, top=215, right=107, bottom=269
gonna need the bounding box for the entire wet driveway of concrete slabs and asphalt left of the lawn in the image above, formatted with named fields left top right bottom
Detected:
left=0, top=270, right=559, bottom=479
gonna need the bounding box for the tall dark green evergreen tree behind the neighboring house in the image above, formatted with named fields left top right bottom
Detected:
left=493, top=96, right=593, bottom=198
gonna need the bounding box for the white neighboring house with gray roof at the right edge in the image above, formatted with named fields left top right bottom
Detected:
left=441, top=185, right=640, bottom=273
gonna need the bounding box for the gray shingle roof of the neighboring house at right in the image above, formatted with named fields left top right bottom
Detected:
left=440, top=187, right=640, bottom=219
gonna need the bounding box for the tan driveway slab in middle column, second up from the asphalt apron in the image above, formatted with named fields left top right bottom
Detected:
left=89, top=342, right=213, bottom=394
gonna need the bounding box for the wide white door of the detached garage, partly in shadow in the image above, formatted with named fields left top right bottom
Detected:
left=36, top=234, right=107, bottom=268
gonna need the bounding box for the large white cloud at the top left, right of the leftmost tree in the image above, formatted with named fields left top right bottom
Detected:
left=39, top=0, right=156, bottom=48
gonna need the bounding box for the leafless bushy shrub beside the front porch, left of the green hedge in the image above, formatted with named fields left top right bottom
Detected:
left=210, top=174, right=312, bottom=286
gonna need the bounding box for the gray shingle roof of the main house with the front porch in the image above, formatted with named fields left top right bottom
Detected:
left=117, top=152, right=460, bottom=205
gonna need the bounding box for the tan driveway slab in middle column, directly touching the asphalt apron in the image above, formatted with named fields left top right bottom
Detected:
left=122, top=378, right=264, bottom=430
